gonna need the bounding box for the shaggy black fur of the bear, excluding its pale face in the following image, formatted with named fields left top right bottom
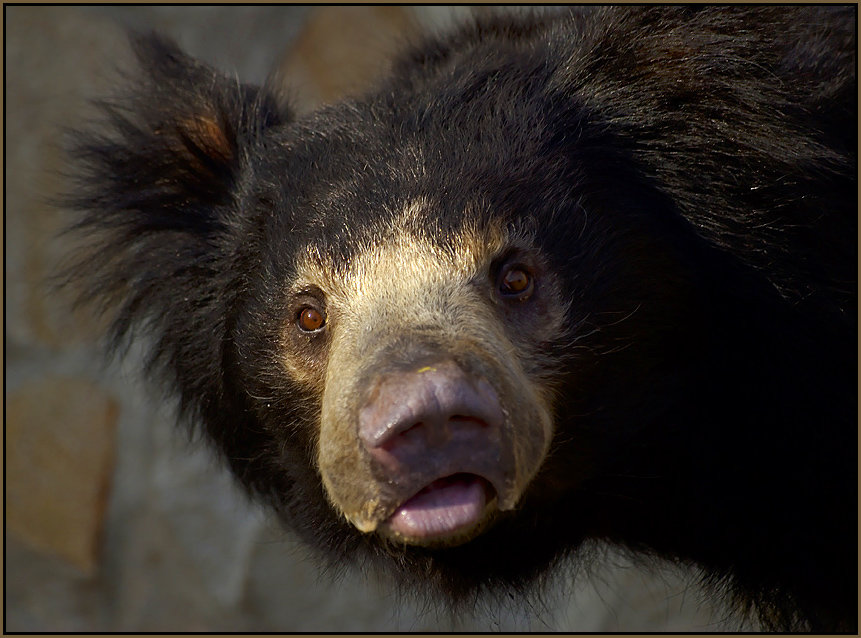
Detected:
left=63, top=6, right=857, bottom=632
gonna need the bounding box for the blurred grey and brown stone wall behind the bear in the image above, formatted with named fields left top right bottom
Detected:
left=4, top=6, right=740, bottom=632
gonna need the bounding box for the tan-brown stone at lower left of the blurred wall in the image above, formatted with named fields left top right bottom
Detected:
left=6, top=377, right=118, bottom=573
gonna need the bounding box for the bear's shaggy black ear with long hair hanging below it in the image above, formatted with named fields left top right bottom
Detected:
left=57, top=35, right=288, bottom=424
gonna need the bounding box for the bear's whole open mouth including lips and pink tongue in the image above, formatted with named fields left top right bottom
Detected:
left=379, top=473, right=497, bottom=546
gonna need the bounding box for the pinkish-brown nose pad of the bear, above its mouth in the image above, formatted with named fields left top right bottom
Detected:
left=358, top=361, right=504, bottom=460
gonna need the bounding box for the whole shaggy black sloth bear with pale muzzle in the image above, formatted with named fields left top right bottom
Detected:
left=69, top=6, right=857, bottom=632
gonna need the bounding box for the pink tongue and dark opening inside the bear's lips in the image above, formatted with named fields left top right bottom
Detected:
left=389, top=478, right=485, bottom=538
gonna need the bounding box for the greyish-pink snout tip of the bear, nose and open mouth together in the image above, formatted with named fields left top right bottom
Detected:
left=358, top=361, right=513, bottom=544
